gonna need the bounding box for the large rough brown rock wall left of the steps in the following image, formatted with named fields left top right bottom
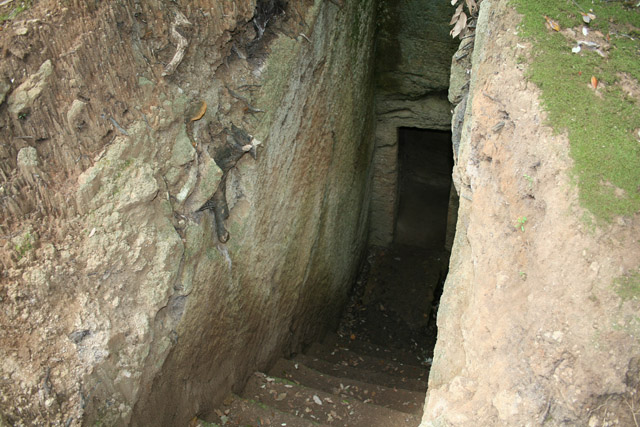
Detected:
left=0, top=0, right=375, bottom=425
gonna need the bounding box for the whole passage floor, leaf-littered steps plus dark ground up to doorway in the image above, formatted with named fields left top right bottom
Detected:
left=205, top=247, right=447, bottom=427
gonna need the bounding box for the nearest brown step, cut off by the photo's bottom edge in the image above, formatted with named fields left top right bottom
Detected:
left=202, top=395, right=322, bottom=427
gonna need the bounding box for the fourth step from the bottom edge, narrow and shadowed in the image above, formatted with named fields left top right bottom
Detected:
left=293, top=354, right=427, bottom=392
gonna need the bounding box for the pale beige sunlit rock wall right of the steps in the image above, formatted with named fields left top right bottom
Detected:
left=421, top=0, right=640, bottom=426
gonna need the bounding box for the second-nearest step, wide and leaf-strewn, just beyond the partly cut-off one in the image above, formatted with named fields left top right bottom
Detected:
left=242, top=373, right=420, bottom=427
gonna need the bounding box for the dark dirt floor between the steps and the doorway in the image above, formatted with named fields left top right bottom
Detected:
left=338, top=245, right=449, bottom=362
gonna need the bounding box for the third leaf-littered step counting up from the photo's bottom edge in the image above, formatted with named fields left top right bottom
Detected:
left=269, top=359, right=425, bottom=417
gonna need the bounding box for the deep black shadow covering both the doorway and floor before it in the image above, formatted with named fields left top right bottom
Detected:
left=341, top=128, right=457, bottom=362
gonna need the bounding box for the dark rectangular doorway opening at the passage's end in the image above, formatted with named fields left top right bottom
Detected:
left=394, top=128, right=453, bottom=249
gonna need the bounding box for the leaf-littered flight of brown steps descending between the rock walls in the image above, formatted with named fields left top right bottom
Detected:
left=202, top=335, right=428, bottom=427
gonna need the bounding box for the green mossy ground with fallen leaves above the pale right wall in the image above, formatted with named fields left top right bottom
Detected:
left=513, top=0, right=640, bottom=221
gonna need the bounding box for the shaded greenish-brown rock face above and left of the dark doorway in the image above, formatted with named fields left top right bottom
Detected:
left=370, top=0, right=456, bottom=246
